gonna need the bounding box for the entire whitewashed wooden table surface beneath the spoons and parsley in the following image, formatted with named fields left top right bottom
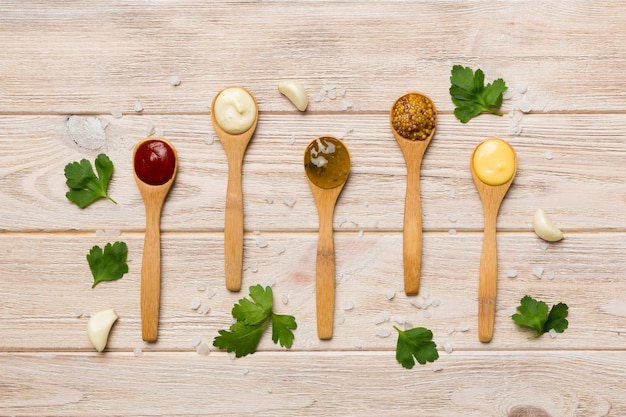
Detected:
left=0, top=0, right=626, bottom=417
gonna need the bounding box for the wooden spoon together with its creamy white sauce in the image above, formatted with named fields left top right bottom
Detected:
left=211, top=87, right=259, bottom=291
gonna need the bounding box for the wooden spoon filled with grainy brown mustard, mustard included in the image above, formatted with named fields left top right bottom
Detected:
left=389, top=92, right=437, bottom=295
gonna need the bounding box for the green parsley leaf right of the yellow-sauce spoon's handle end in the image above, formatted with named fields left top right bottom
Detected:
left=511, top=295, right=569, bottom=338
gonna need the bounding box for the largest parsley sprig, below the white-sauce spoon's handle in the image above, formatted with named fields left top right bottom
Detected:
left=213, top=285, right=298, bottom=358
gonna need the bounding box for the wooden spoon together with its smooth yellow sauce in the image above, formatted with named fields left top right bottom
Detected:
left=470, top=138, right=517, bottom=343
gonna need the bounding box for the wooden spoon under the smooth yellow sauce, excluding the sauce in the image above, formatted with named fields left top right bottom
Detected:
left=470, top=138, right=517, bottom=343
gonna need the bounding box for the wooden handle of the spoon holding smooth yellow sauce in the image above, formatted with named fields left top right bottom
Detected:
left=478, top=210, right=498, bottom=343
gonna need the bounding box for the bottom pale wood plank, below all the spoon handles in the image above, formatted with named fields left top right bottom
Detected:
left=0, top=351, right=626, bottom=417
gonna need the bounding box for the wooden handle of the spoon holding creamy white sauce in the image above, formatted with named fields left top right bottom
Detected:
left=224, top=154, right=243, bottom=292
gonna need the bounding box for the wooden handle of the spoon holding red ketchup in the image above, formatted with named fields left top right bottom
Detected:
left=141, top=203, right=161, bottom=342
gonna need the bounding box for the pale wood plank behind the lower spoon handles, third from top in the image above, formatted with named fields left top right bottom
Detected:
left=0, top=231, right=626, bottom=352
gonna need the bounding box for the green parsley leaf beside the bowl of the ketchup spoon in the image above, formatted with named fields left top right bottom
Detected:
left=65, top=153, right=117, bottom=208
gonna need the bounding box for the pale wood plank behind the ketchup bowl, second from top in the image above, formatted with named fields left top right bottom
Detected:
left=0, top=114, right=626, bottom=231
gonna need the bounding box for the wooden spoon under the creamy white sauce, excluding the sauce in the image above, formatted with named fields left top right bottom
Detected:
left=211, top=87, right=259, bottom=291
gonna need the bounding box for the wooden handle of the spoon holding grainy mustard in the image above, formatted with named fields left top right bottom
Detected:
left=403, top=162, right=422, bottom=295
